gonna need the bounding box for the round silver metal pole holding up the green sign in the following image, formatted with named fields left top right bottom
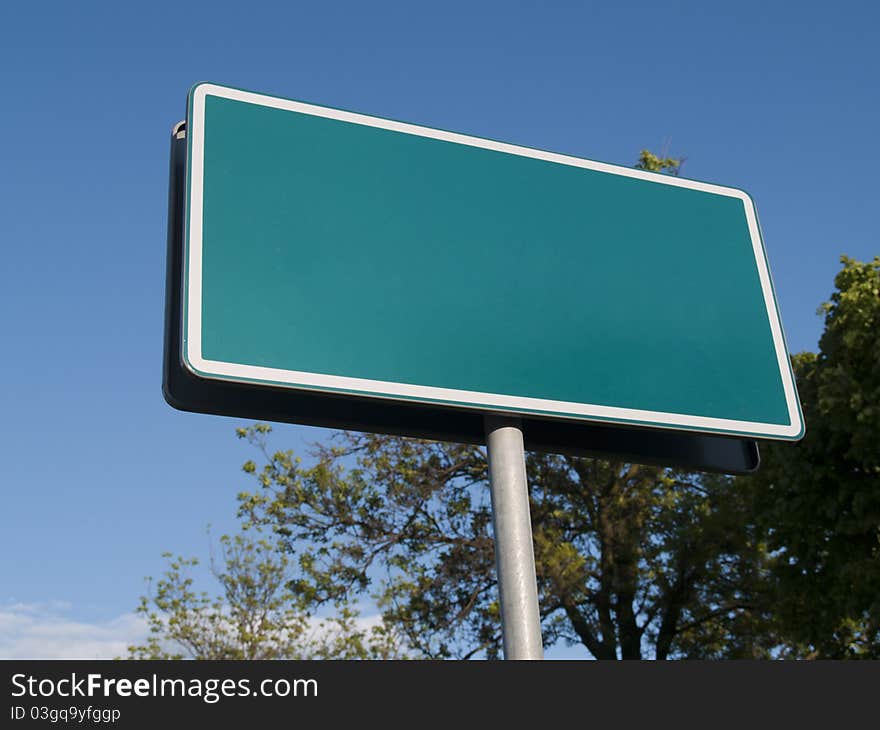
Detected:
left=485, top=416, right=544, bottom=659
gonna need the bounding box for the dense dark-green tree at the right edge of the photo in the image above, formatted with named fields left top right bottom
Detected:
left=743, top=256, right=880, bottom=658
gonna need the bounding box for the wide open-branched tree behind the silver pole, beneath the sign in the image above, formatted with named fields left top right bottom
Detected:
left=239, top=424, right=769, bottom=659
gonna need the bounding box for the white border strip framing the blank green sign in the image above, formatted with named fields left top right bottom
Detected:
left=184, top=84, right=803, bottom=439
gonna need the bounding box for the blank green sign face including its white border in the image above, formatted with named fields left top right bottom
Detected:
left=183, top=84, right=803, bottom=439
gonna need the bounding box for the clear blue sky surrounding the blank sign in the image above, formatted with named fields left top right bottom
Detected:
left=0, top=0, right=880, bottom=656
